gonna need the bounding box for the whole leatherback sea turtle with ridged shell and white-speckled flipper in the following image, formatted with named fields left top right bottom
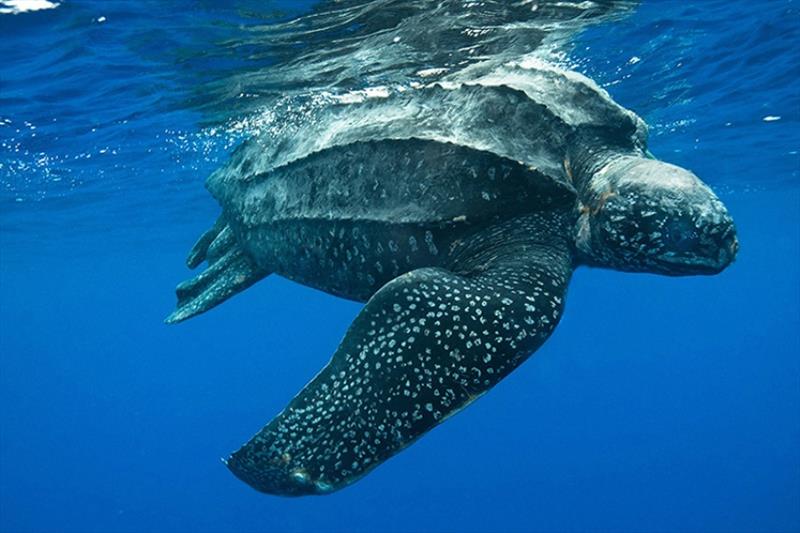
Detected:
left=167, top=62, right=738, bottom=495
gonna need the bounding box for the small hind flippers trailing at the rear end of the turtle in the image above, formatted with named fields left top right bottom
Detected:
left=165, top=217, right=269, bottom=324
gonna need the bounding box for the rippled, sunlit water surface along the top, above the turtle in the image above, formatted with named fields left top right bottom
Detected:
left=0, top=0, right=800, bottom=247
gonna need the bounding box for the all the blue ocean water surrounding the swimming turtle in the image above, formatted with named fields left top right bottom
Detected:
left=0, top=0, right=800, bottom=532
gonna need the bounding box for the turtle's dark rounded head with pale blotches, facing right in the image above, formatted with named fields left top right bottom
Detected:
left=576, top=156, right=739, bottom=276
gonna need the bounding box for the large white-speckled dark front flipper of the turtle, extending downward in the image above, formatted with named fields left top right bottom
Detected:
left=227, top=214, right=572, bottom=496
